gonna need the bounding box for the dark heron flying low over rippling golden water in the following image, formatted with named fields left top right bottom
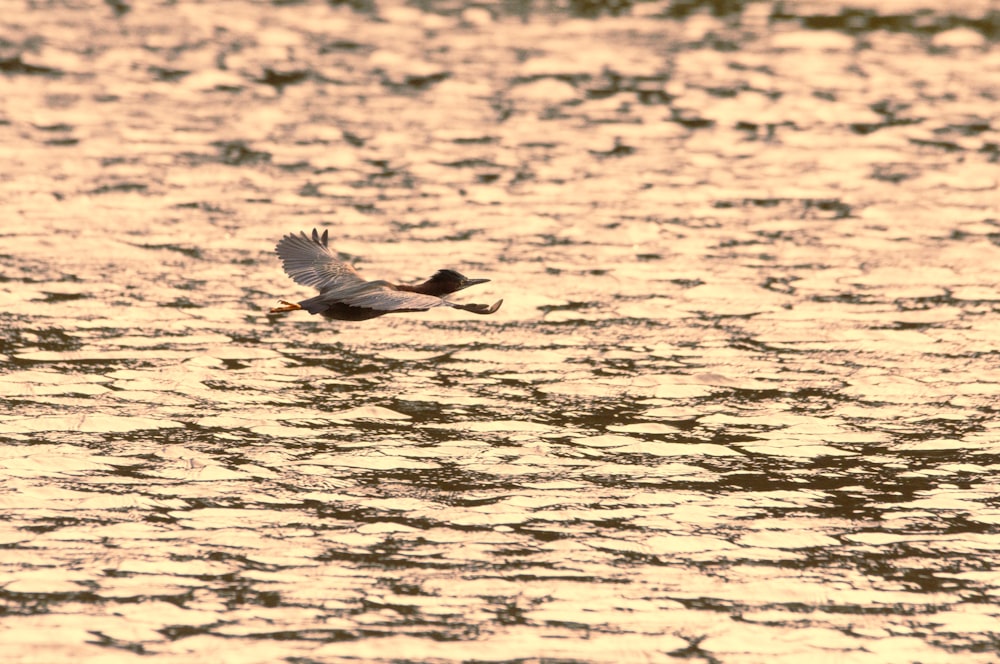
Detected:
left=270, top=228, right=503, bottom=321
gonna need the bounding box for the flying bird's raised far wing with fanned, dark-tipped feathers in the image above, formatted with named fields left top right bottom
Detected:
left=274, top=228, right=367, bottom=293
